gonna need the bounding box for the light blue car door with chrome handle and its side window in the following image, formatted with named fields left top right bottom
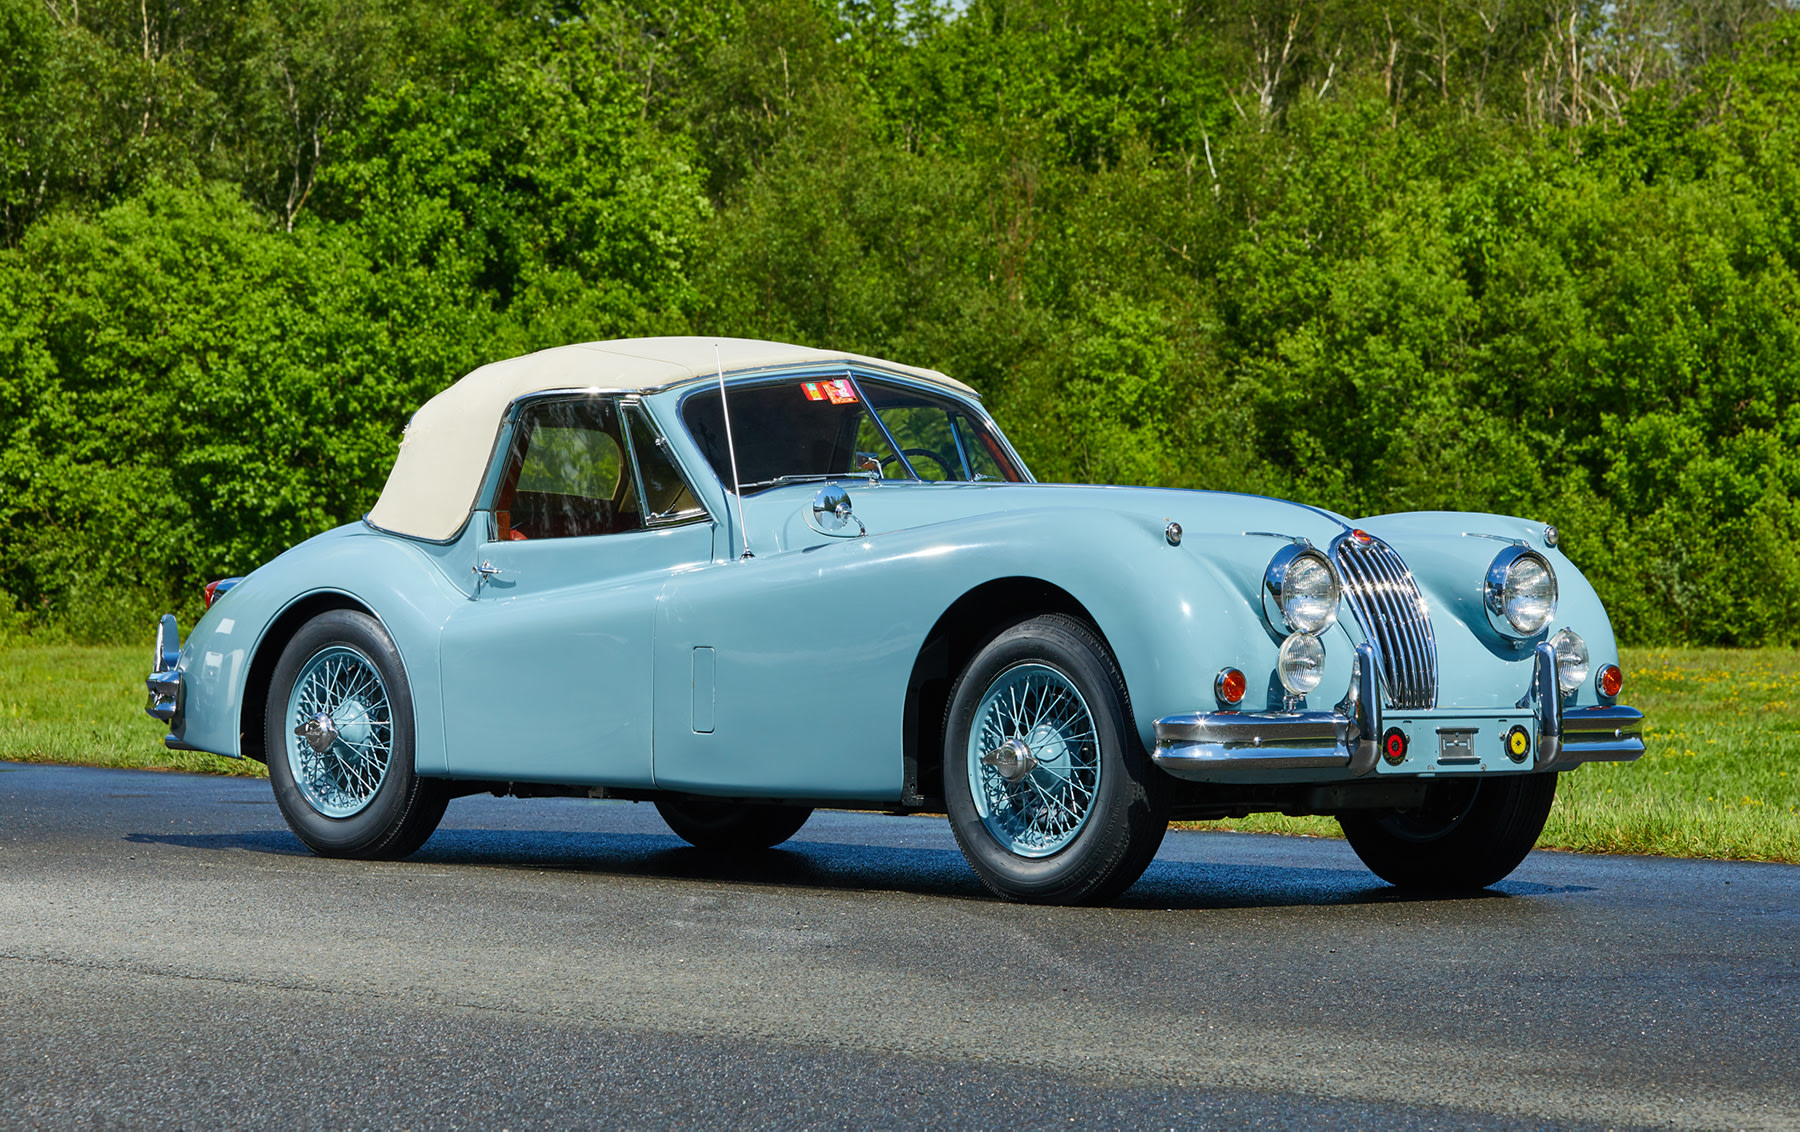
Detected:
left=439, top=396, right=713, bottom=786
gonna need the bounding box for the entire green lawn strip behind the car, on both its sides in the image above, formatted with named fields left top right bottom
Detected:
left=0, top=644, right=1800, bottom=862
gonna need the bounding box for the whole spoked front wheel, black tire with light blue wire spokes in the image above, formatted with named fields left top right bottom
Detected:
left=943, top=614, right=1168, bottom=903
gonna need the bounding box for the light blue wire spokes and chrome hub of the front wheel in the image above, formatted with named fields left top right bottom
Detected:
left=968, top=664, right=1100, bottom=857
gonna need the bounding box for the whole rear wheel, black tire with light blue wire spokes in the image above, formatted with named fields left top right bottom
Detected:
left=263, top=610, right=450, bottom=860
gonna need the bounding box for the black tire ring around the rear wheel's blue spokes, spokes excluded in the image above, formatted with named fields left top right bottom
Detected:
left=263, top=610, right=418, bottom=857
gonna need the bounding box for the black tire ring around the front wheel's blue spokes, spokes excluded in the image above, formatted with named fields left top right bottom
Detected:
left=943, top=615, right=1166, bottom=902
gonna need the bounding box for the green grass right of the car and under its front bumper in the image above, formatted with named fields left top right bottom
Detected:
left=1184, top=648, right=1800, bottom=864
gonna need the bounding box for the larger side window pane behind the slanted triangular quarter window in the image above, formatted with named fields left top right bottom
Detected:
left=493, top=398, right=643, bottom=540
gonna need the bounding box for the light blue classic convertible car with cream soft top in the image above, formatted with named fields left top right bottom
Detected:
left=148, top=338, right=1643, bottom=903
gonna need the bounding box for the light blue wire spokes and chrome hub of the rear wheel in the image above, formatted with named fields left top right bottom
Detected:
left=288, top=644, right=394, bottom=817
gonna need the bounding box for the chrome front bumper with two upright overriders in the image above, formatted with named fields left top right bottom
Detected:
left=1152, top=644, right=1643, bottom=783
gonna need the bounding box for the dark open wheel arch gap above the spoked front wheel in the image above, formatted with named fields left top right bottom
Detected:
left=902, top=576, right=1112, bottom=810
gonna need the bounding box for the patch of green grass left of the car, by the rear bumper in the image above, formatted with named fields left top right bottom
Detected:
left=0, top=644, right=265, bottom=776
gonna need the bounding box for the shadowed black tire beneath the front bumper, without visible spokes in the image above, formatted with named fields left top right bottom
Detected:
left=1337, top=774, right=1557, bottom=893
